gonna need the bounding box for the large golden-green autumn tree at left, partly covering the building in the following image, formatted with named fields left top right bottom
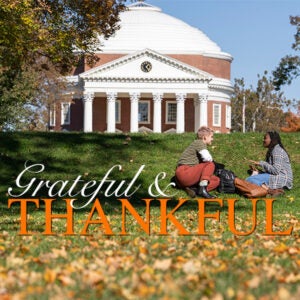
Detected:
left=0, top=0, right=125, bottom=128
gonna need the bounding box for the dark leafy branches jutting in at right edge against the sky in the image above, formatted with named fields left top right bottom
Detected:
left=273, top=16, right=300, bottom=90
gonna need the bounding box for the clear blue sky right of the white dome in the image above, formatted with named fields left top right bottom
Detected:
left=127, top=0, right=300, bottom=100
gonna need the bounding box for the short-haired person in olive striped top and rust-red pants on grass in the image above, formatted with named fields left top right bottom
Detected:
left=175, top=126, right=220, bottom=198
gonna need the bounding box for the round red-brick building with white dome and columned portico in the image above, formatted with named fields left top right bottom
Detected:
left=51, top=1, right=233, bottom=133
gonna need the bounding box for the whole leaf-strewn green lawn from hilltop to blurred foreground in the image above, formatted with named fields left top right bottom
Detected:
left=0, top=132, right=300, bottom=300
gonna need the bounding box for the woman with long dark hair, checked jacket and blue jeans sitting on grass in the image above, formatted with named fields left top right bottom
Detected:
left=246, top=131, right=293, bottom=194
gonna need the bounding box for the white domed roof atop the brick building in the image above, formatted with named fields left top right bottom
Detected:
left=99, top=1, right=232, bottom=60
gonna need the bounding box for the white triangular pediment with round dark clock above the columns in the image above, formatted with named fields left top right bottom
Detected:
left=80, top=49, right=214, bottom=82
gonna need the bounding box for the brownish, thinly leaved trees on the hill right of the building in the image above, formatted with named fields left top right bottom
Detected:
left=231, top=72, right=292, bottom=132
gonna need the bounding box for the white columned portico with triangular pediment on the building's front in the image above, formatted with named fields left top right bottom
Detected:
left=79, top=49, right=230, bottom=133
